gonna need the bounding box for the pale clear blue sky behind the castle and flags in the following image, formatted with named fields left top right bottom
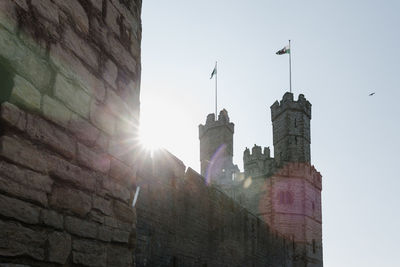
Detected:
left=141, top=0, right=400, bottom=267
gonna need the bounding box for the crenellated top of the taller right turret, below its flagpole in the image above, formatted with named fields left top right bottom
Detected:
left=271, top=92, right=311, bottom=120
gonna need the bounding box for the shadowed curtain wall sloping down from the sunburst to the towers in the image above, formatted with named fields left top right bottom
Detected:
left=136, top=151, right=293, bottom=266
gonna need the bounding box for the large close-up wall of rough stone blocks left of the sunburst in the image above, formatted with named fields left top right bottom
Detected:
left=0, top=0, right=142, bottom=266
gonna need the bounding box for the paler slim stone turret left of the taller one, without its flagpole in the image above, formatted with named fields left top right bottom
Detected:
left=199, top=109, right=238, bottom=187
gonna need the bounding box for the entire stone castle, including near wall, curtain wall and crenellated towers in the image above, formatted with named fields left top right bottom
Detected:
left=0, top=0, right=322, bottom=267
